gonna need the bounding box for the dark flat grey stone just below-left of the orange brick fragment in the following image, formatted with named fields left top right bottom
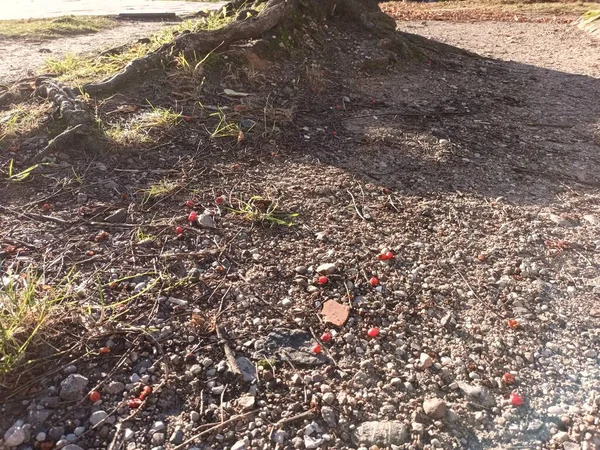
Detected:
left=265, top=328, right=328, bottom=366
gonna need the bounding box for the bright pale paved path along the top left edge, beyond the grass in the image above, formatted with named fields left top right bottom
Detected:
left=0, top=0, right=222, bottom=20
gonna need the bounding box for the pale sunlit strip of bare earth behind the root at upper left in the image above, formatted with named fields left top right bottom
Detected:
left=0, top=22, right=172, bottom=83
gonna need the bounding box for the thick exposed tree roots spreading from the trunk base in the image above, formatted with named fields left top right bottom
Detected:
left=14, top=0, right=469, bottom=162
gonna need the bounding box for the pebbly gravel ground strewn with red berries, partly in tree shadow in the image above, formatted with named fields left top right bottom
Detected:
left=0, top=15, right=600, bottom=450
